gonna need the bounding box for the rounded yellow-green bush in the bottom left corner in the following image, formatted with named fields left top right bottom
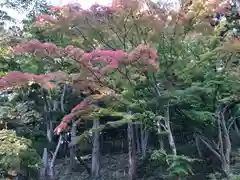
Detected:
left=0, top=130, right=41, bottom=176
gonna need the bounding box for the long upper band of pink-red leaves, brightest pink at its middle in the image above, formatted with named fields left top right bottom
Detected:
left=11, top=40, right=158, bottom=74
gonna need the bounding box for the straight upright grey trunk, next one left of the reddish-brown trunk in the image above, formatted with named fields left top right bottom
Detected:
left=91, top=120, right=100, bottom=178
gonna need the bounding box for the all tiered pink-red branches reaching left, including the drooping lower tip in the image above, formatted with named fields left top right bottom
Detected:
left=1, top=34, right=156, bottom=180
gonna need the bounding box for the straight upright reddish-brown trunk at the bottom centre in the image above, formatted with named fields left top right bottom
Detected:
left=128, top=122, right=137, bottom=180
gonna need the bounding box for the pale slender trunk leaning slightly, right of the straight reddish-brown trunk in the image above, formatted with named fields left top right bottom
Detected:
left=164, top=104, right=177, bottom=156
